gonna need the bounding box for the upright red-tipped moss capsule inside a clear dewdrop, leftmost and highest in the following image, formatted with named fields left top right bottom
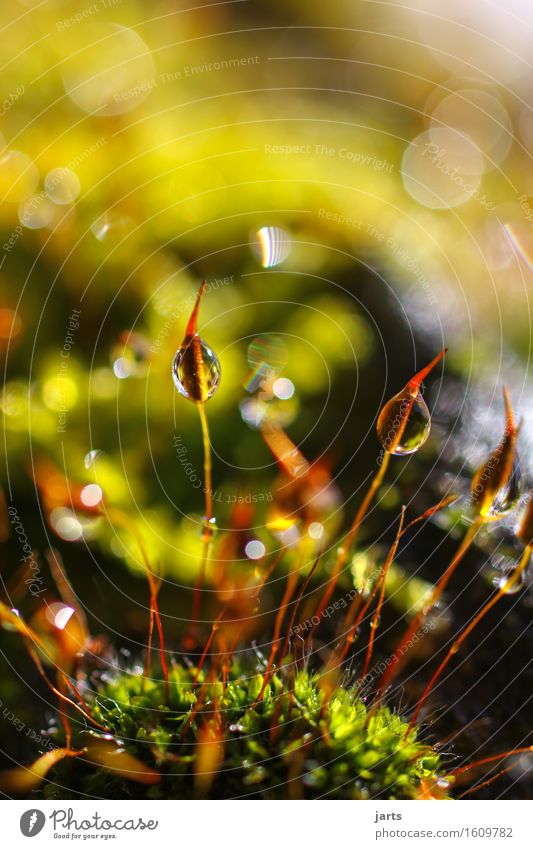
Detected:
left=172, top=280, right=221, bottom=404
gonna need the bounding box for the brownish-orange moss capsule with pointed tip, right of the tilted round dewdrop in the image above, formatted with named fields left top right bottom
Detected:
left=472, top=387, right=521, bottom=522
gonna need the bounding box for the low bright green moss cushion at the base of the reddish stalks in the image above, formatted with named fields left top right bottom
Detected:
left=44, top=664, right=442, bottom=799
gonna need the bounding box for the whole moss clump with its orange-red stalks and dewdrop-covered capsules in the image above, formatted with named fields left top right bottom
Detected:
left=0, top=285, right=533, bottom=799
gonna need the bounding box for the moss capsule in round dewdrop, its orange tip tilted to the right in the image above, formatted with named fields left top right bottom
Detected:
left=377, top=348, right=448, bottom=456
